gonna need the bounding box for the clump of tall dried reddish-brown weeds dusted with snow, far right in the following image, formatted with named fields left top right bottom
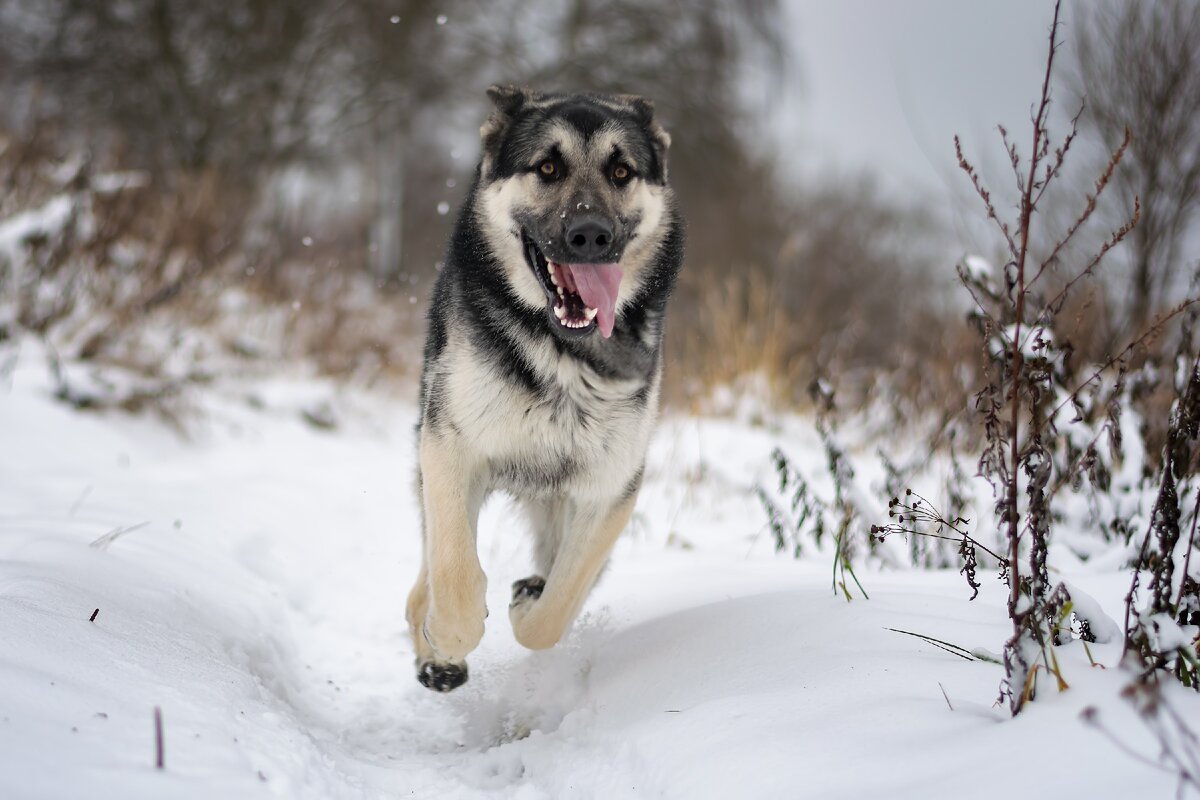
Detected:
left=902, top=0, right=1200, bottom=714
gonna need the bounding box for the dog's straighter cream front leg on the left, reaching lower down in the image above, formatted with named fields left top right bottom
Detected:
left=409, top=431, right=487, bottom=692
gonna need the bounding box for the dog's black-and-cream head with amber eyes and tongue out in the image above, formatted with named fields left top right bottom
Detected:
left=479, top=86, right=672, bottom=338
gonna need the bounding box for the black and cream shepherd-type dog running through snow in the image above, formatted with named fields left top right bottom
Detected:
left=407, top=86, right=684, bottom=692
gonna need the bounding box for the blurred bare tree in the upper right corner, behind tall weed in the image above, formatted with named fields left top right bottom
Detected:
left=1073, top=0, right=1200, bottom=341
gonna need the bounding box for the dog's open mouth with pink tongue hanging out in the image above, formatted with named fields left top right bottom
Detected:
left=522, top=231, right=622, bottom=338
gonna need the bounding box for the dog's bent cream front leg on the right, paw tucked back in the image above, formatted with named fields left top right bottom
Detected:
left=509, top=493, right=637, bottom=650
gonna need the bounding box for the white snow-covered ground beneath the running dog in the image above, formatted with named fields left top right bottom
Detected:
left=0, top=347, right=1200, bottom=800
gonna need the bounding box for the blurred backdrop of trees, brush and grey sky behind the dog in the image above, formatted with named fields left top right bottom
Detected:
left=0, top=0, right=1200, bottom=416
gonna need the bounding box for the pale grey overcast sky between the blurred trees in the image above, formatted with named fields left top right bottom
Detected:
left=778, top=0, right=1070, bottom=209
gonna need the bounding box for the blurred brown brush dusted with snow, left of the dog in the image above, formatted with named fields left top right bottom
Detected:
left=0, top=125, right=429, bottom=411
